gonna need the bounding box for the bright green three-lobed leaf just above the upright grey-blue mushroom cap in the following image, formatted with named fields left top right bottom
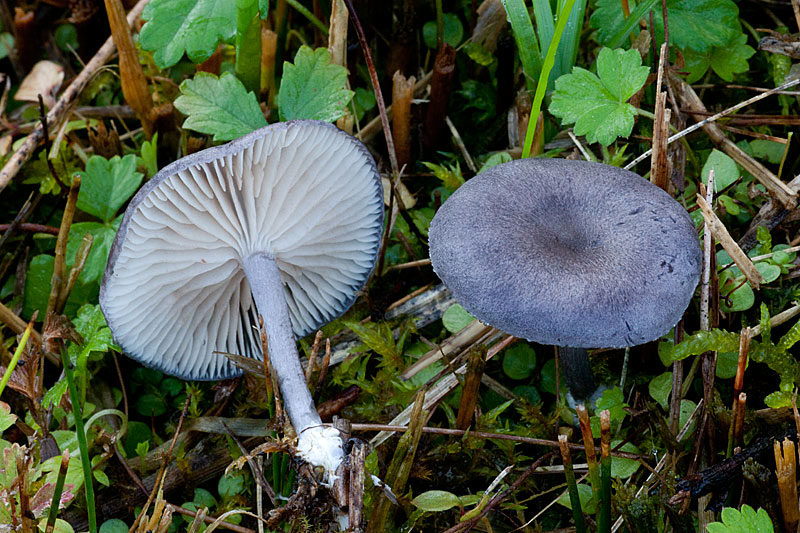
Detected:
left=550, top=48, right=650, bottom=146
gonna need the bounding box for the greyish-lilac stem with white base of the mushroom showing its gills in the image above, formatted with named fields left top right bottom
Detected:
left=242, top=253, right=344, bottom=483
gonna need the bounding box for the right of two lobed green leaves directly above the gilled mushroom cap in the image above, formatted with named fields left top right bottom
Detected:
left=278, top=46, right=353, bottom=122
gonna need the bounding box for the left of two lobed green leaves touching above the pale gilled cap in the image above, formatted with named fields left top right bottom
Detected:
left=175, top=72, right=267, bottom=141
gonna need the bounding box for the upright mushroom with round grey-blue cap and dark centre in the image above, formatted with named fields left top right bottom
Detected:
left=429, top=159, right=701, bottom=401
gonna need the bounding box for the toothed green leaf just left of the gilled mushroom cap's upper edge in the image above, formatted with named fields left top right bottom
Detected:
left=77, top=154, right=144, bottom=222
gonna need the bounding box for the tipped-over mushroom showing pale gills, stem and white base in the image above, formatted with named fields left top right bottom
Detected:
left=100, top=120, right=383, bottom=483
